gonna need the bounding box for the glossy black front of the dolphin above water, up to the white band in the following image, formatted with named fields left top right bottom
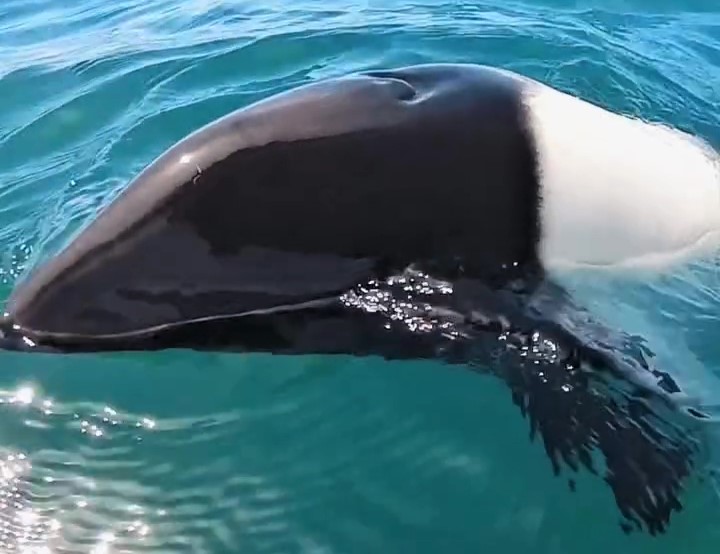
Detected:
left=0, top=61, right=537, bottom=342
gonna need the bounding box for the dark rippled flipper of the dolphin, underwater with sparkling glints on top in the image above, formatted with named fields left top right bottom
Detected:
left=343, top=270, right=707, bottom=535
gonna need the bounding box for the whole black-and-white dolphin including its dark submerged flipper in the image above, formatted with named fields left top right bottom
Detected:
left=1, top=64, right=720, bottom=534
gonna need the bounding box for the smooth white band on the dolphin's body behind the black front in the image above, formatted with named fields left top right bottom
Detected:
left=523, top=80, right=720, bottom=271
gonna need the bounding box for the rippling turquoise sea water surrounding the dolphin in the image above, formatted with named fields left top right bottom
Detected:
left=0, top=0, right=720, bottom=554
